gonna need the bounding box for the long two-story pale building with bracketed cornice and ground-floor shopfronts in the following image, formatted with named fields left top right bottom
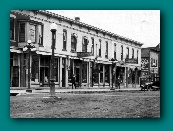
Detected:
left=10, top=10, right=142, bottom=88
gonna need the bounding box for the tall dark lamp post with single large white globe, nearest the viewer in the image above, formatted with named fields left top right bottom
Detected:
left=50, top=23, right=57, bottom=96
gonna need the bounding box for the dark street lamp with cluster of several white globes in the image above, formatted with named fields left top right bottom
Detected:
left=24, top=40, right=35, bottom=92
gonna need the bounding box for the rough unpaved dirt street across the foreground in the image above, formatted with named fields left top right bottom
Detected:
left=10, top=91, right=160, bottom=118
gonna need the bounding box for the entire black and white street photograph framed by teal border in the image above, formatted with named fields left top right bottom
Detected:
left=9, top=10, right=160, bottom=118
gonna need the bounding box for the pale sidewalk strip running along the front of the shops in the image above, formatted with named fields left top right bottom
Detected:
left=10, top=86, right=141, bottom=94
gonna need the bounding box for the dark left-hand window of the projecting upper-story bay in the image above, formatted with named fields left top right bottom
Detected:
left=19, top=23, right=26, bottom=42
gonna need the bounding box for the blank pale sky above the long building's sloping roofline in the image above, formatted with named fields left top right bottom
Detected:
left=48, top=10, right=160, bottom=47
